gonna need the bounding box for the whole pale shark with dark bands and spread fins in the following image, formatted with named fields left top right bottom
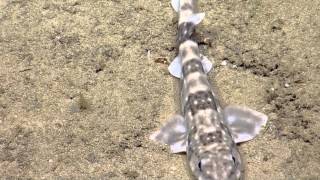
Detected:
left=150, top=0, right=268, bottom=180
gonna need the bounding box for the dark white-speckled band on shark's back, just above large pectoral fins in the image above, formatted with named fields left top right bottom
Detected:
left=184, top=91, right=217, bottom=115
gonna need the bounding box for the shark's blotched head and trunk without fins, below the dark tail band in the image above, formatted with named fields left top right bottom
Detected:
left=180, top=40, right=241, bottom=179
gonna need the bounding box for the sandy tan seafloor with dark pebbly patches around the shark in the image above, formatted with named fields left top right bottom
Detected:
left=0, top=0, right=320, bottom=180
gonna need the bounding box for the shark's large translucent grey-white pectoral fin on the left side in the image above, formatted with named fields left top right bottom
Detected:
left=150, top=115, right=187, bottom=153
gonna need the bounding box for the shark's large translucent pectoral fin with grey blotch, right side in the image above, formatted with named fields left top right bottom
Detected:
left=224, top=106, right=268, bottom=143
